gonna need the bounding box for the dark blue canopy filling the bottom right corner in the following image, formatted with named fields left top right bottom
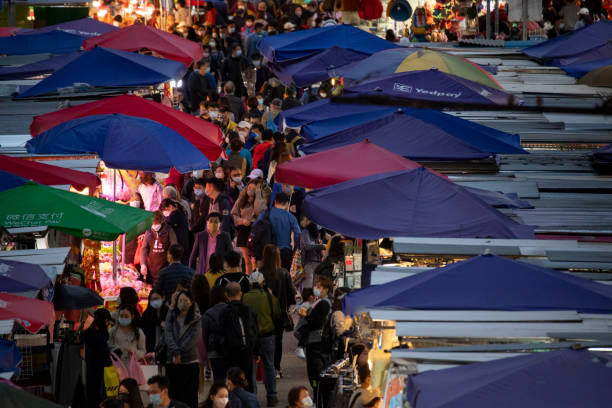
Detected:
left=406, top=350, right=612, bottom=408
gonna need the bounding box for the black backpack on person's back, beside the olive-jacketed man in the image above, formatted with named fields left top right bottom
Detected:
left=215, top=304, right=257, bottom=356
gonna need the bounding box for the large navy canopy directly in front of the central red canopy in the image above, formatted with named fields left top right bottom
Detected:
left=304, top=167, right=534, bottom=239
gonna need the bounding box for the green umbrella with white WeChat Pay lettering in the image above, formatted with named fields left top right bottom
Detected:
left=0, top=179, right=153, bottom=241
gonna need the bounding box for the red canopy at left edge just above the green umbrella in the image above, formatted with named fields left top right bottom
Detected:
left=0, top=154, right=100, bottom=190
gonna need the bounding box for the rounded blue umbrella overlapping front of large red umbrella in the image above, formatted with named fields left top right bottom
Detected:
left=26, top=114, right=210, bottom=173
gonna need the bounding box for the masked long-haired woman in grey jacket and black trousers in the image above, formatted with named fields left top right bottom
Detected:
left=164, top=291, right=201, bottom=408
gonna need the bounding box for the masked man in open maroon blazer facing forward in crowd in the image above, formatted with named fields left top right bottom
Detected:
left=189, top=212, right=234, bottom=275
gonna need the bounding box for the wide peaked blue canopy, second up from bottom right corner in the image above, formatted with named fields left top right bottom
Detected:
left=343, top=253, right=612, bottom=314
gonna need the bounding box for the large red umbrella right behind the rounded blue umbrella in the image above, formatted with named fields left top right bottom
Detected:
left=30, top=94, right=223, bottom=161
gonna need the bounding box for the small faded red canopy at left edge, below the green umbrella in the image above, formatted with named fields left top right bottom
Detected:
left=0, top=293, right=55, bottom=333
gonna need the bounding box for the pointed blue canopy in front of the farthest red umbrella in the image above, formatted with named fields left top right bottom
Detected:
left=19, top=47, right=187, bottom=98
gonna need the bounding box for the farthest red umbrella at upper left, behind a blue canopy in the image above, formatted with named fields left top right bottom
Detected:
left=83, top=24, right=202, bottom=66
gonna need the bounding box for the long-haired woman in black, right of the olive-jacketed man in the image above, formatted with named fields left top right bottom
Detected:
left=261, top=244, right=295, bottom=378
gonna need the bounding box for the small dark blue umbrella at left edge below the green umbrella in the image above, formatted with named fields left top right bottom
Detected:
left=0, top=260, right=51, bottom=293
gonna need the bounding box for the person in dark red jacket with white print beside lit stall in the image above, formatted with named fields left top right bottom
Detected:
left=140, top=211, right=177, bottom=284
